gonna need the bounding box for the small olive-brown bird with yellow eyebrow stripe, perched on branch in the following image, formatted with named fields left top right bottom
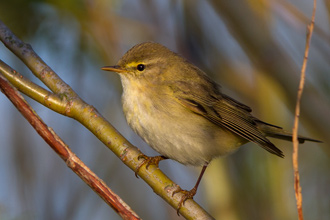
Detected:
left=102, top=42, right=320, bottom=211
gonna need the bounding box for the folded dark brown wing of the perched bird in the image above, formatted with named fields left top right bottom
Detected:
left=173, top=81, right=284, bottom=157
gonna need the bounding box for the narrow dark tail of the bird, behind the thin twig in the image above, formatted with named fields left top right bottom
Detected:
left=257, top=120, right=322, bottom=143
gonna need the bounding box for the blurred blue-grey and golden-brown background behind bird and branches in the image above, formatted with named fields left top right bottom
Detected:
left=0, top=0, right=330, bottom=220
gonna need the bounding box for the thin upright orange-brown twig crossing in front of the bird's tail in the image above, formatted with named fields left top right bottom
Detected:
left=292, top=0, right=316, bottom=220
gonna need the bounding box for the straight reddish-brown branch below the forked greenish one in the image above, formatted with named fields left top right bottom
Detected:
left=0, top=75, right=140, bottom=219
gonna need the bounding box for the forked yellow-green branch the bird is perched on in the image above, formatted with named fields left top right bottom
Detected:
left=0, top=21, right=212, bottom=219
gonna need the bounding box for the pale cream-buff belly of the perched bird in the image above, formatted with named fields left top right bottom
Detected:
left=123, top=91, right=246, bottom=165
